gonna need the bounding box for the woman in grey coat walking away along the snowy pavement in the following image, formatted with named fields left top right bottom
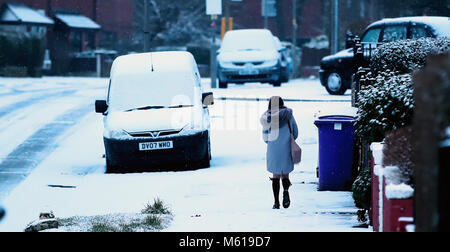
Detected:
left=261, top=96, right=298, bottom=209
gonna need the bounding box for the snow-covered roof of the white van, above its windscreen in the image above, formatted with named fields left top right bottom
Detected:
left=111, top=51, right=196, bottom=76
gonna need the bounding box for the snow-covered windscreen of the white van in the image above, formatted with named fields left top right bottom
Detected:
left=108, top=73, right=196, bottom=111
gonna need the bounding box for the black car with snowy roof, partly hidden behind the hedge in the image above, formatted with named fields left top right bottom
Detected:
left=320, top=17, right=450, bottom=95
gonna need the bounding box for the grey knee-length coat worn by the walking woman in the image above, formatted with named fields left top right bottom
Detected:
left=261, top=108, right=298, bottom=175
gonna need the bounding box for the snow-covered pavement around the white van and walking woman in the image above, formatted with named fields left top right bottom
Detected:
left=0, top=79, right=369, bottom=232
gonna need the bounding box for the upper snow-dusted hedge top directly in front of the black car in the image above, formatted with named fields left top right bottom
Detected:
left=370, top=37, right=450, bottom=75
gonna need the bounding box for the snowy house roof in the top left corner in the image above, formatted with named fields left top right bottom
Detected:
left=0, top=3, right=54, bottom=26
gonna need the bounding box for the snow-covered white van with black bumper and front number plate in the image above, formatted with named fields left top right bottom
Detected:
left=96, top=52, right=214, bottom=172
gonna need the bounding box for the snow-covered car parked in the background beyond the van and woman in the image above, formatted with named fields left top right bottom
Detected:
left=217, top=29, right=282, bottom=88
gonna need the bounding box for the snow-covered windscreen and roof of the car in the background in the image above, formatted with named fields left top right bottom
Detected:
left=221, top=31, right=276, bottom=51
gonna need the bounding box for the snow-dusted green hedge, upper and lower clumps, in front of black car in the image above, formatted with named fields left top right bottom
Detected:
left=357, top=38, right=450, bottom=143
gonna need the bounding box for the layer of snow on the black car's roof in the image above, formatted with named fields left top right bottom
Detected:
left=369, top=16, right=450, bottom=37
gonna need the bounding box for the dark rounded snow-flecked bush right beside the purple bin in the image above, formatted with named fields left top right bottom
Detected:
left=357, top=71, right=415, bottom=143
